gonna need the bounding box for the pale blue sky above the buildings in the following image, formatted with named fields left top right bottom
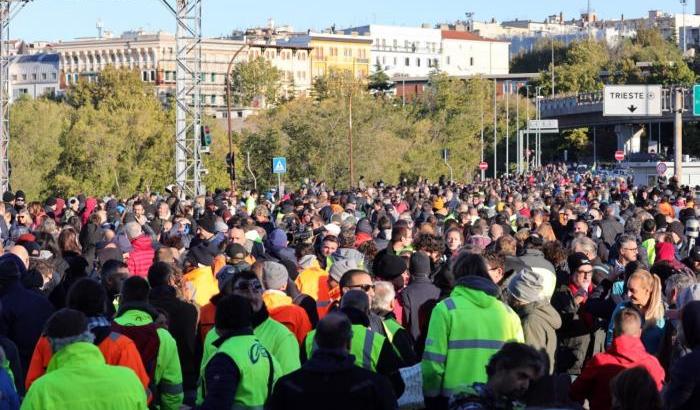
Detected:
left=10, top=0, right=694, bottom=41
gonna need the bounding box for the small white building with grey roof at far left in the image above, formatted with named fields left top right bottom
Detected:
left=9, top=54, right=60, bottom=101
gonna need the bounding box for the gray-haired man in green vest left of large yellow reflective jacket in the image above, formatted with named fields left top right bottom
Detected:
left=371, top=281, right=419, bottom=366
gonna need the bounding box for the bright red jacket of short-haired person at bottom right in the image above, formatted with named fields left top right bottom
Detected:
left=570, top=335, right=665, bottom=410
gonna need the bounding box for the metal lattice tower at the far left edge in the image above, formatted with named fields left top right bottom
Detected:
left=0, top=0, right=31, bottom=192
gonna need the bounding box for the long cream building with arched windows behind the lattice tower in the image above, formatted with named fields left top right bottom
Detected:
left=26, top=31, right=312, bottom=112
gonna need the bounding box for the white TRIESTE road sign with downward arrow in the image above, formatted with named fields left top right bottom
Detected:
left=603, top=85, right=661, bottom=117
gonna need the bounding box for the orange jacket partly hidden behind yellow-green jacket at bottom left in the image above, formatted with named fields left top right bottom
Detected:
left=25, top=332, right=151, bottom=394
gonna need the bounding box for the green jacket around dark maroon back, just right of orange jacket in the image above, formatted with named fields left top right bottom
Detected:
left=114, top=309, right=185, bottom=410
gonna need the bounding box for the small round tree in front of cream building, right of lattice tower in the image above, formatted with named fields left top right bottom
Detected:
left=231, top=57, right=282, bottom=108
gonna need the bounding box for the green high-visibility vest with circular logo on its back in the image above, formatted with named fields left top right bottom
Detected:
left=202, top=335, right=281, bottom=410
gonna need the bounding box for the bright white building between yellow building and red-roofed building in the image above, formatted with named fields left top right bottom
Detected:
left=343, top=24, right=441, bottom=77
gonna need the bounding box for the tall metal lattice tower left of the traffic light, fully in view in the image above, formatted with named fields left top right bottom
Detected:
left=161, top=0, right=205, bottom=197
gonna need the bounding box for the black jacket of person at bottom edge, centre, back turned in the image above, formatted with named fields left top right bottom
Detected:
left=269, top=349, right=397, bottom=410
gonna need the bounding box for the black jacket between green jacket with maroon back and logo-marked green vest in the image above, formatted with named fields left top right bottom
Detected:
left=149, top=286, right=201, bottom=390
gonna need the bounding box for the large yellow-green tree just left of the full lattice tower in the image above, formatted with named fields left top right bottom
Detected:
left=48, top=67, right=174, bottom=195
